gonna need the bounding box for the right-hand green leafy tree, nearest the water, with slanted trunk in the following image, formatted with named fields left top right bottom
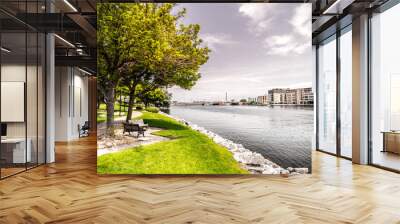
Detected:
left=120, top=4, right=210, bottom=120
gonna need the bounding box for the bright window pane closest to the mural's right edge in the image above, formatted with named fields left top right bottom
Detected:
left=318, top=37, right=336, bottom=153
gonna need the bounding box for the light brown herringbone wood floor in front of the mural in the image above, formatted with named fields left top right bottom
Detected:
left=0, top=138, right=400, bottom=224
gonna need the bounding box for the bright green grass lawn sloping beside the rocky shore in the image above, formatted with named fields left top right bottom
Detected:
left=97, top=112, right=248, bottom=174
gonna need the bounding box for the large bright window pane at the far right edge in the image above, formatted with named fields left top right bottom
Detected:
left=371, top=2, right=400, bottom=170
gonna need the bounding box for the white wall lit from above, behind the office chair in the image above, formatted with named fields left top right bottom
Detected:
left=55, top=67, right=88, bottom=141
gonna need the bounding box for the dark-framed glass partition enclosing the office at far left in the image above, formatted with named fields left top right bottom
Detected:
left=0, top=1, right=46, bottom=179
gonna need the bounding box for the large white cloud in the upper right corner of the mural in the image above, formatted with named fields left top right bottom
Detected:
left=238, top=3, right=311, bottom=56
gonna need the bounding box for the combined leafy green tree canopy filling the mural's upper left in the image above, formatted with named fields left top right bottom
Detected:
left=97, top=3, right=210, bottom=130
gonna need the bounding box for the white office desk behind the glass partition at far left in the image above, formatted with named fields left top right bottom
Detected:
left=1, top=138, right=32, bottom=164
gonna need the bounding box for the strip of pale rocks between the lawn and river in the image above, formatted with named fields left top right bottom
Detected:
left=160, top=112, right=308, bottom=176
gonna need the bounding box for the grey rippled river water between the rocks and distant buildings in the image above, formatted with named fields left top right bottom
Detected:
left=170, top=105, right=313, bottom=169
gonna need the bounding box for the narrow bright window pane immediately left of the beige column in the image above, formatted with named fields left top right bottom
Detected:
left=340, top=30, right=352, bottom=158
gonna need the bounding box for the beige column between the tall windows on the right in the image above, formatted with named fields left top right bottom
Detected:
left=352, top=15, right=368, bottom=164
